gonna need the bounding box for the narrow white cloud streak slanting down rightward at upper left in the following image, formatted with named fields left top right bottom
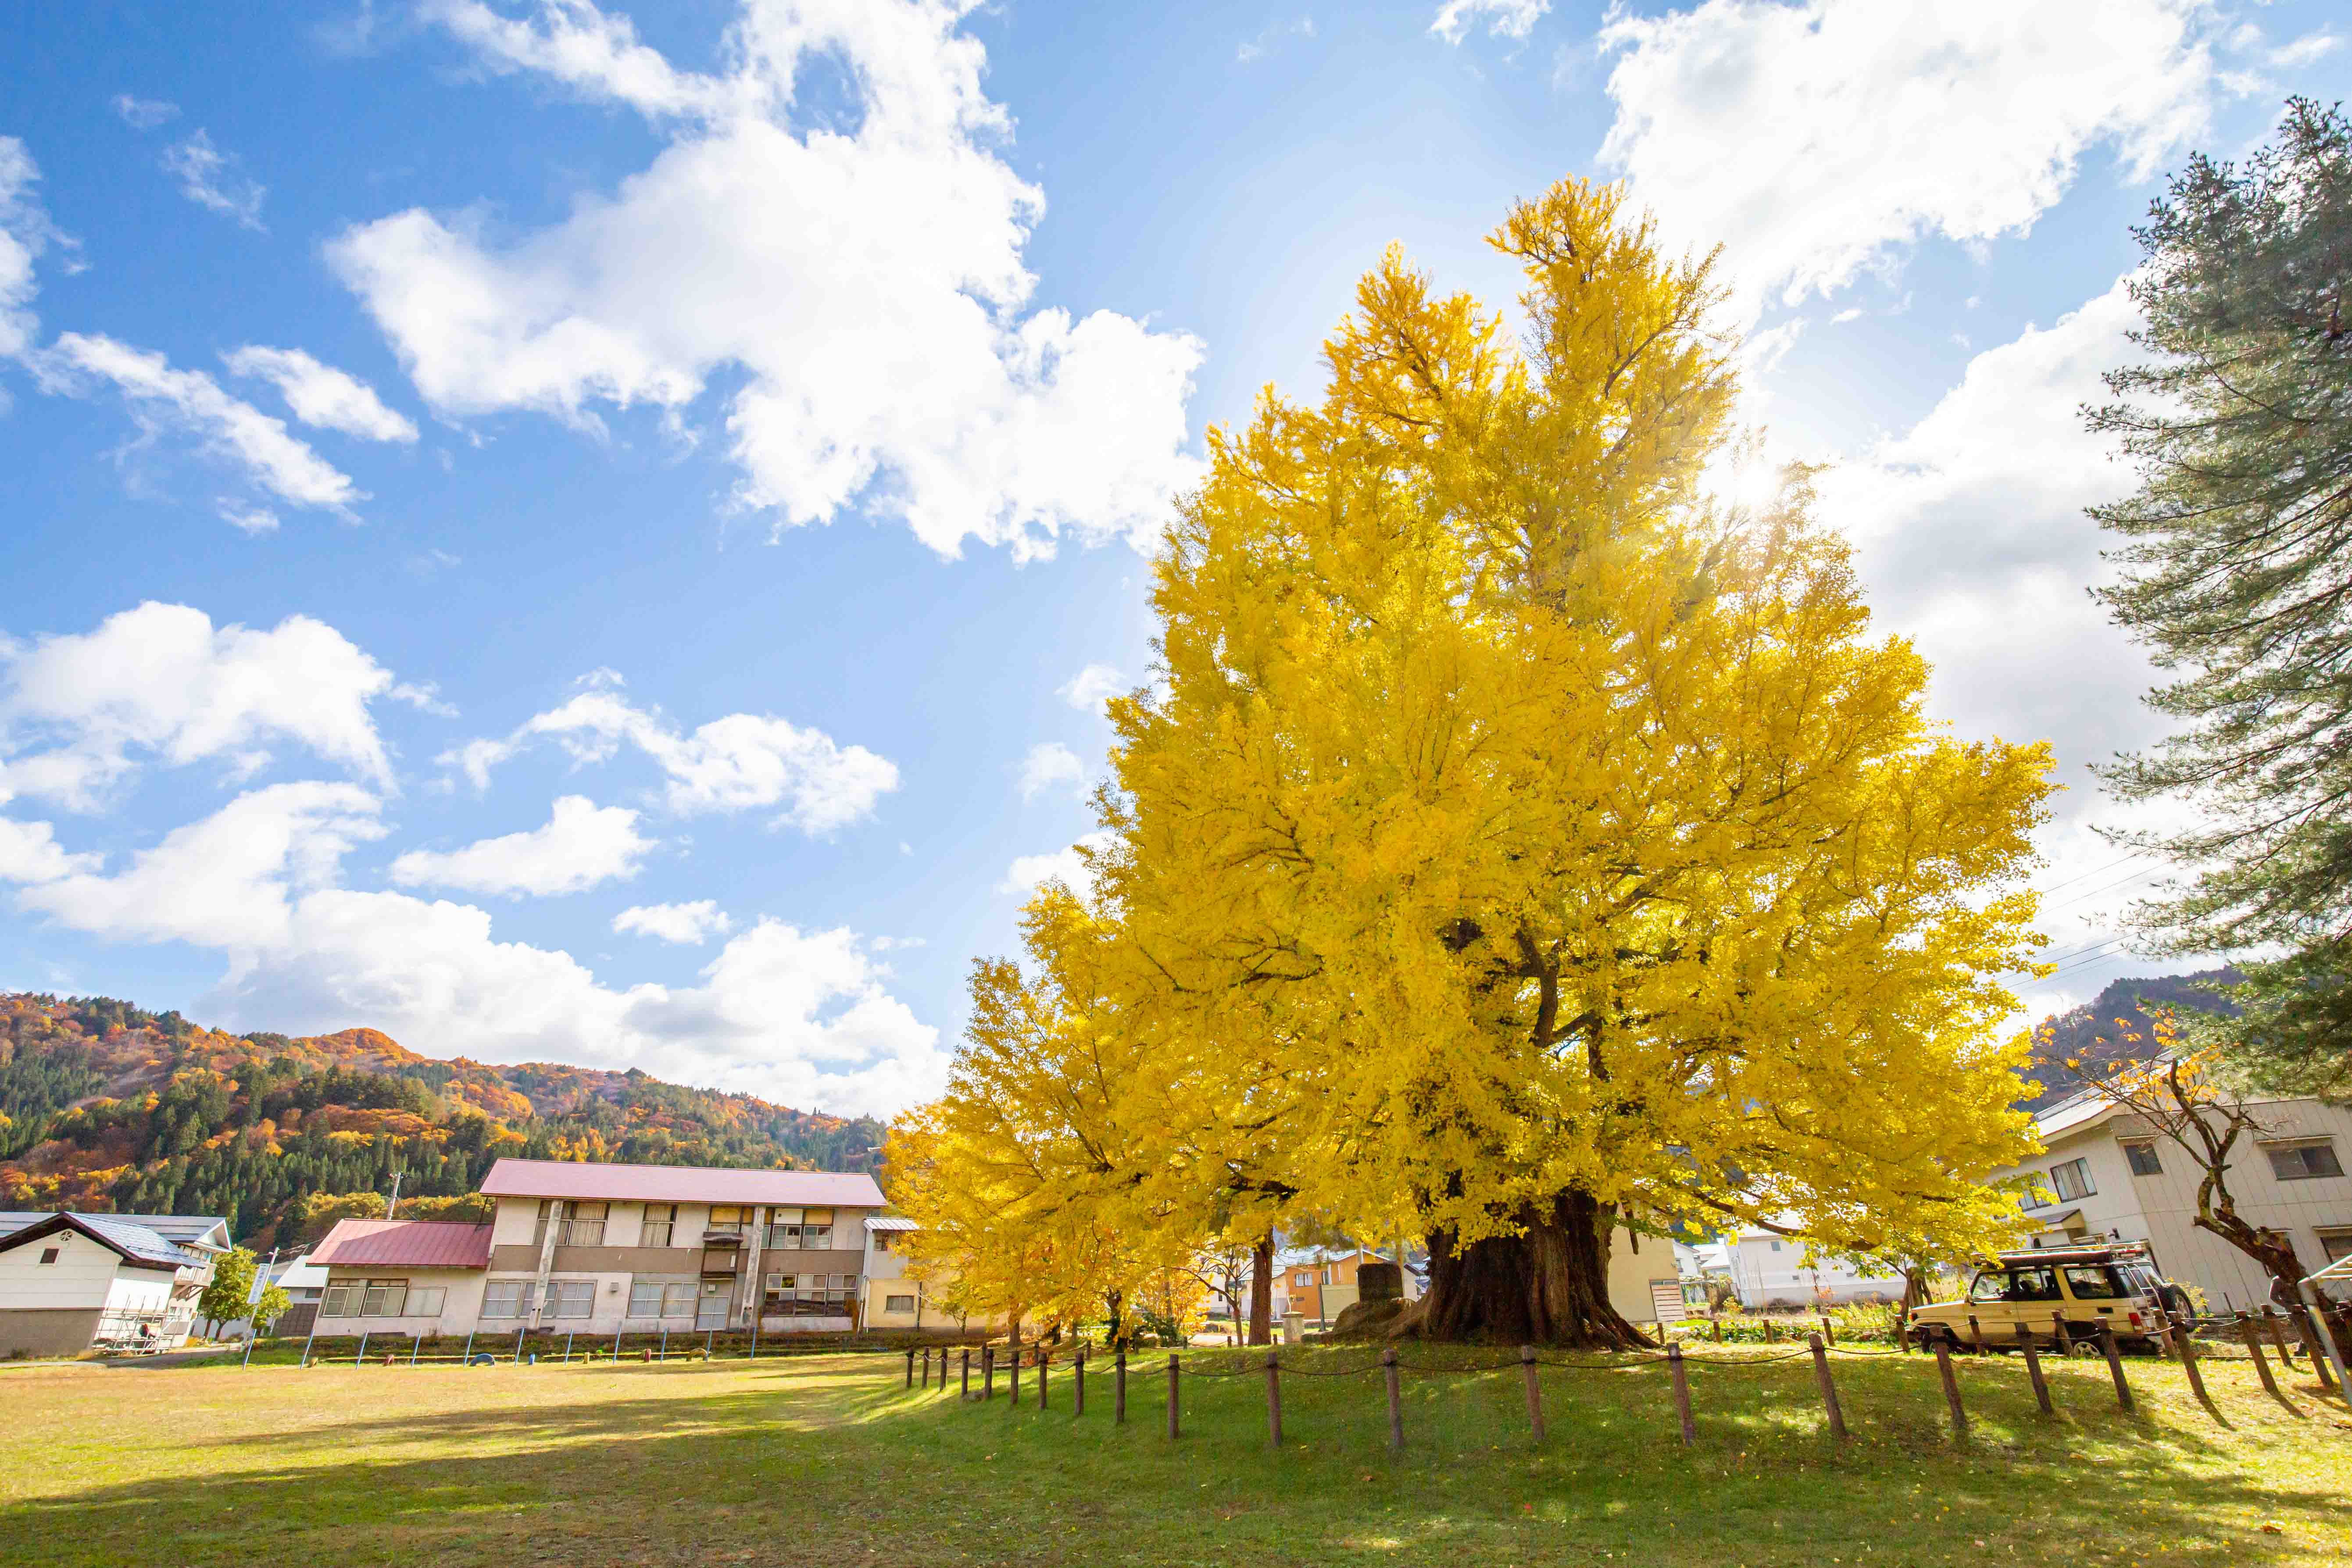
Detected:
left=33, top=332, right=367, bottom=517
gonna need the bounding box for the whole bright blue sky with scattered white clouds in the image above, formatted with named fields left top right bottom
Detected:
left=0, top=0, right=2352, bottom=1114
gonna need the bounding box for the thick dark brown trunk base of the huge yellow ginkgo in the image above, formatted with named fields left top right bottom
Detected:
left=1397, top=1192, right=1651, bottom=1350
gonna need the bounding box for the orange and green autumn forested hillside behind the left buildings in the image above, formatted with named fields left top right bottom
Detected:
left=0, top=992, right=882, bottom=1246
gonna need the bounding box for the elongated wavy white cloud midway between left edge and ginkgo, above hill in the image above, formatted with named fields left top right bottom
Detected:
left=440, top=682, right=898, bottom=835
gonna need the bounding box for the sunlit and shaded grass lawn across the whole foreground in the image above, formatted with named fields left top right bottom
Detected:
left=0, top=1350, right=2352, bottom=1568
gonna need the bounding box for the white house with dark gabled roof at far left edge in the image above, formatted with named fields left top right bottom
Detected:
left=0, top=1213, right=228, bottom=1357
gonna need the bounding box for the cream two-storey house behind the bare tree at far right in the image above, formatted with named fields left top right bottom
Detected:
left=1995, top=1091, right=2352, bottom=1312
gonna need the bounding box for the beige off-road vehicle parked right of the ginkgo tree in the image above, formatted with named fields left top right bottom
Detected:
left=1910, top=1243, right=2180, bottom=1350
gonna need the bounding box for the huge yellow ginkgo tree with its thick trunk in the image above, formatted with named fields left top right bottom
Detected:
left=889, top=179, right=2051, bottom=1342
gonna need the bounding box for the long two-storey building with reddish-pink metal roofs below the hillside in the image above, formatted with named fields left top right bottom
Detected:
left=313, top=1159, right=896, bottom=1335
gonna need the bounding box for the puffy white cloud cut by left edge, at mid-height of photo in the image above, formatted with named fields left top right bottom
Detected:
left=0, top=600, right=414, bottom=811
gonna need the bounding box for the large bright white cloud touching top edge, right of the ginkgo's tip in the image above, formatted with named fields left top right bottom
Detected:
left=1599, top=0, right=2220, bottom=308
